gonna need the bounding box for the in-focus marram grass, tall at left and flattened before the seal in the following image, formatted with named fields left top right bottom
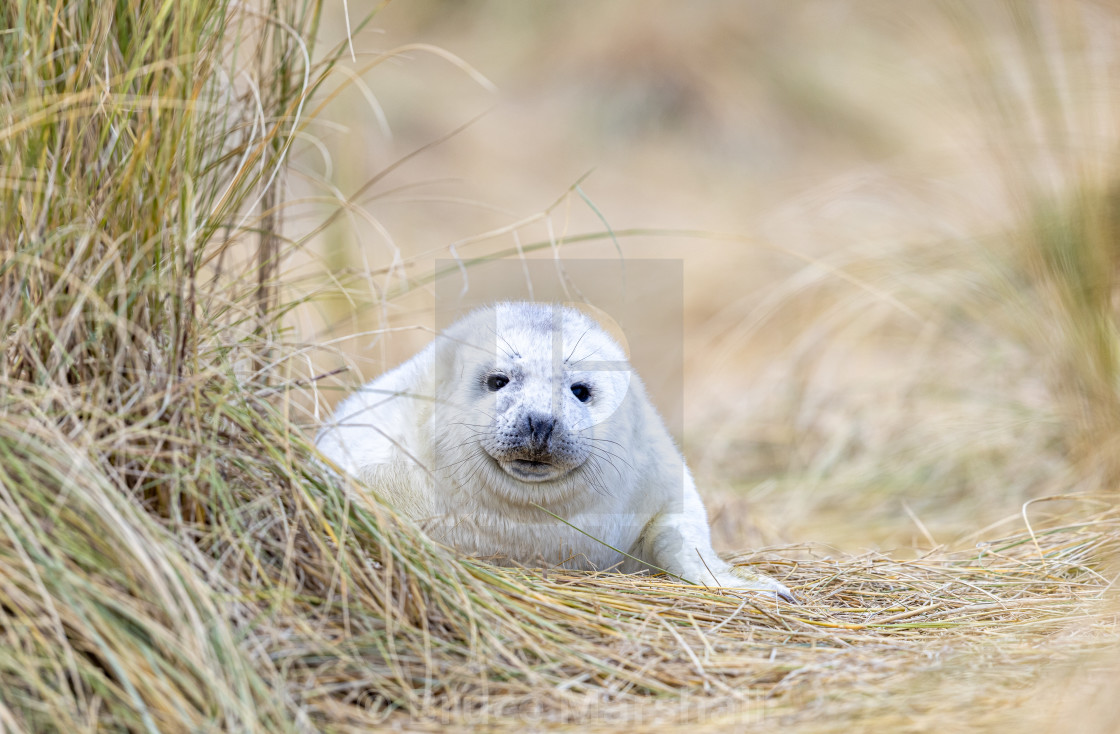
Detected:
left=0, top=0, right=1120, bottom=733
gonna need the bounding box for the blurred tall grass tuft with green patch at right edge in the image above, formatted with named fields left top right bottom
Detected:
left=946, top=2, right=1120, bottom=493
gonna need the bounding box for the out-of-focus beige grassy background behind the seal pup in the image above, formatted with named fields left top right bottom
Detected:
left=304, top=1, right=1118, bottom=550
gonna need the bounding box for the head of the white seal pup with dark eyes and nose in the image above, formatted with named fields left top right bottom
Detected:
left=436, top=303, right=631, bottom=502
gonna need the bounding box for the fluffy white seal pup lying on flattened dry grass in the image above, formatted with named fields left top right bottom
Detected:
left=316, top=303, right=793, bottom=601
